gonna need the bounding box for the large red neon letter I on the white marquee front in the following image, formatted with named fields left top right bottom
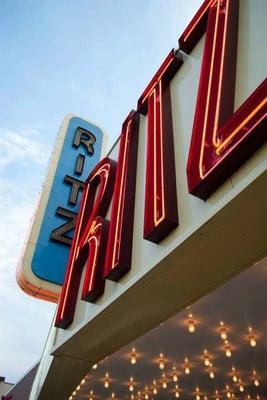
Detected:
left=105, top=111, right=139, bottom=281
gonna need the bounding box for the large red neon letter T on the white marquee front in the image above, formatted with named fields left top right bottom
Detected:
left=137, top=50, right=183, bottom=243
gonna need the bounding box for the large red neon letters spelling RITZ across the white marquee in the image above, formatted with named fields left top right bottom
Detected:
left=56, top=0, right=267, bottom=328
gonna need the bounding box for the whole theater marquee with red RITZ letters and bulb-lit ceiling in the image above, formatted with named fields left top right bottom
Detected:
left=15, top=0, right=267, bottom=400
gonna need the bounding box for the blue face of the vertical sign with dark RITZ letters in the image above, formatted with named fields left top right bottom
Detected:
left=31, top=117, right=103, bottom=285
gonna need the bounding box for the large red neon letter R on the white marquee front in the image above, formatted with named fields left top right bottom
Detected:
left=55, top=158, right=116, bottom=328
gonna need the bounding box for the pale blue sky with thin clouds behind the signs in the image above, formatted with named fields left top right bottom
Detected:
left=0, top=0, right=202, bottom=382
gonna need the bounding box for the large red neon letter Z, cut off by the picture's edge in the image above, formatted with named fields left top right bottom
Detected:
left=179, top=0, right=267, bottom=200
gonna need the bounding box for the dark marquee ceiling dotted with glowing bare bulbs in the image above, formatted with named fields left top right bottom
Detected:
left=69, top=254, right=267, bottom=400
